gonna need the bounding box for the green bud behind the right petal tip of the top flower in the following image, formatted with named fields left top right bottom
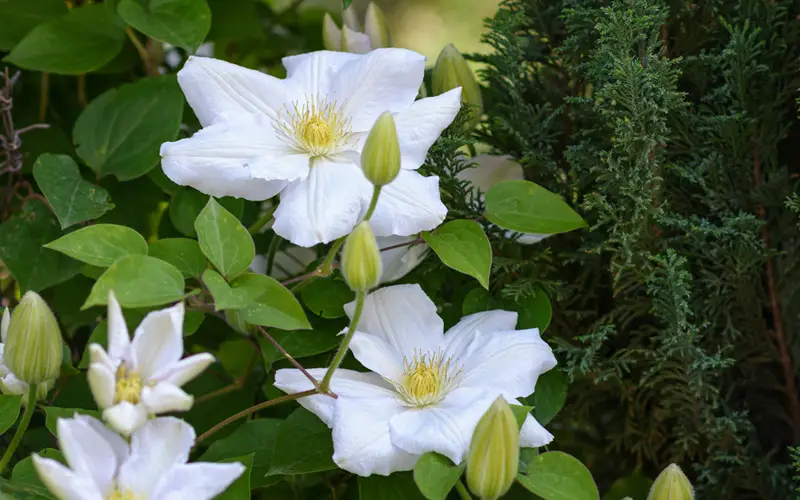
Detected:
left=431, top=43, right=483, bottom=124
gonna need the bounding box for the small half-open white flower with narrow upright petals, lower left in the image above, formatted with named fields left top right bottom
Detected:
left=88, top=293, right=214, bottom=436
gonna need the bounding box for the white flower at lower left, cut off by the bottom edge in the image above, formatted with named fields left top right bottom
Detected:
left=33, top=415, right=245, bottom=500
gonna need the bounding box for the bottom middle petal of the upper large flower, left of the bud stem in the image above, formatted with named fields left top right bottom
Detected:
left=272, top=158, right=372, bottom=247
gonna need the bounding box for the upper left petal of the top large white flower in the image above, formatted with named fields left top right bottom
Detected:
left=178, top=56, right=287, bottom=127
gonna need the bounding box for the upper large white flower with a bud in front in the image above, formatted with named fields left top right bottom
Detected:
left=161, top=49, right=461, bottom=247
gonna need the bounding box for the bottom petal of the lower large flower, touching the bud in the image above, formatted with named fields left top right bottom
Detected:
left=389, top=388, right=498, bottom=464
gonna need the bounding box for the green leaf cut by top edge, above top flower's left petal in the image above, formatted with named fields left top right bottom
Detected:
left=117, top=0, right=211, bottom=52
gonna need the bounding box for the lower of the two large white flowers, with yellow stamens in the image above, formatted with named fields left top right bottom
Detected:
left=275, top=285, right=556, bottom=476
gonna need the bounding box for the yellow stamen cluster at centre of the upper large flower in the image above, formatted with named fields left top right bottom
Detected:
left=275, top=99, right=351, bottom=157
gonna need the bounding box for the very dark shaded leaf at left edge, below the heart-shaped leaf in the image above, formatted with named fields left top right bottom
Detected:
left=0, top=198, right=80, bottom=292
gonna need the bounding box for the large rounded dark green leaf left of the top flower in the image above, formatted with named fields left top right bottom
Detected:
left=72, top=75, right=183, bottom=181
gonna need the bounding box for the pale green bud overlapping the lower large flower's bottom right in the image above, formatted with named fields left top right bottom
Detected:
left=467, top=397, right=519, bottom=500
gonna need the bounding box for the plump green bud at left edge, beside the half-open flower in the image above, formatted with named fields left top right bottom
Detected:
left=5, top=292, right=63, bottom=384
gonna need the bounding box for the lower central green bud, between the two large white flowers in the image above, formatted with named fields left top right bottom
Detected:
left=342, top=221, right=383, bottom=292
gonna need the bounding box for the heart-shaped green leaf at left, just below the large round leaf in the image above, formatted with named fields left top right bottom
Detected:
left=33, top=154, right=114, bottom=229
